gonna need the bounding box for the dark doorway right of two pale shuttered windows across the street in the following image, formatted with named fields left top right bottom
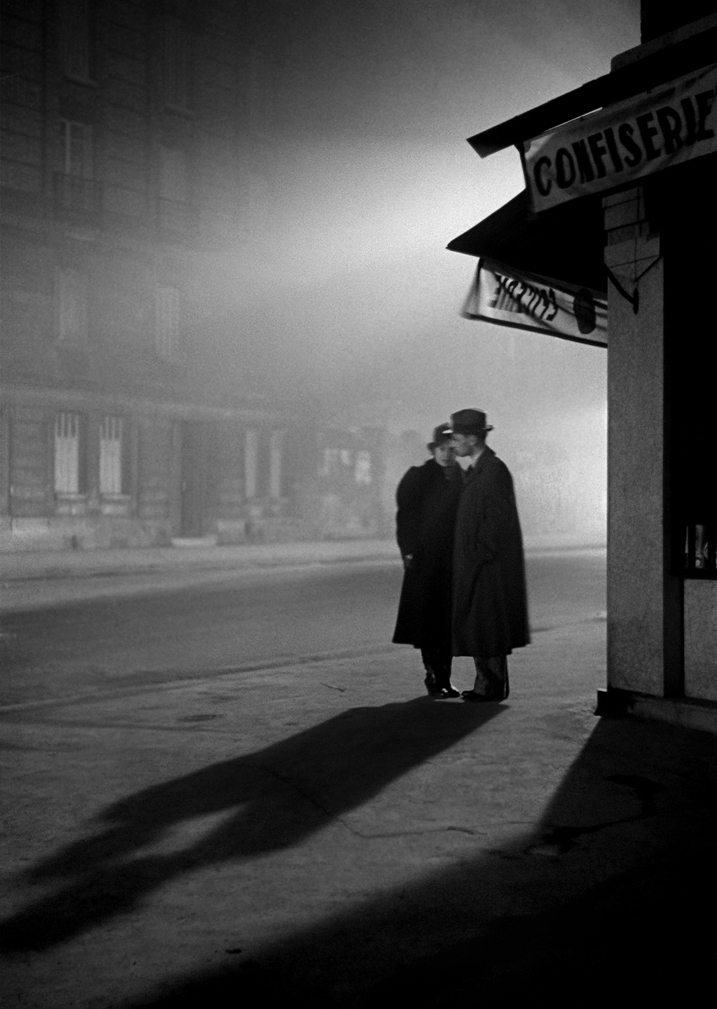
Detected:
left=180, top=421, right=217, bottom=536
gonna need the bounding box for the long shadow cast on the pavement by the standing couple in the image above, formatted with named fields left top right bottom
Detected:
left=0, top=696, right=502, bottom=950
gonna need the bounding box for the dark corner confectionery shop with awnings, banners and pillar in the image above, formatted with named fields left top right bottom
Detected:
left=449, top=4, right=717, bottom=731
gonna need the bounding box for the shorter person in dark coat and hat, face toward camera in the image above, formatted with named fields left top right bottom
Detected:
left=393, top=424, right=462, bottom=697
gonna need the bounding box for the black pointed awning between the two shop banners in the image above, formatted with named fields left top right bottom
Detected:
left=448, top=190, right=607, bottom=292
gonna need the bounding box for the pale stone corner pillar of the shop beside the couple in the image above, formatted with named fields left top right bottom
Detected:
left=603, top=188, right=683, bottom=697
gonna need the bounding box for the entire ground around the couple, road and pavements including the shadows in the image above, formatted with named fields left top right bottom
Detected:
left=0, top=551, right=717, bottom=1009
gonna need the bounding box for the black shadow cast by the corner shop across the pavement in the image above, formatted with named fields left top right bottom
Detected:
left=118, top=720, right=717, bottom=1009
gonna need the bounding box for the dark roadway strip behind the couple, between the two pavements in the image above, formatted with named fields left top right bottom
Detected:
left=2, top=550, right=605, bottom=704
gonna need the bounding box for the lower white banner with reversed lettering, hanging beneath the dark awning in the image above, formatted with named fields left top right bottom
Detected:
left=463, top=259, right=607, bottom=346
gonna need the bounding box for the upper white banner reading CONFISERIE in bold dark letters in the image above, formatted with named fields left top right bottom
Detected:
left=522, top=67, right=717, bottom=211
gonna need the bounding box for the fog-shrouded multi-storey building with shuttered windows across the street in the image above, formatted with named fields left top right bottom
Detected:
left=0, top=0, right=387, bottom=549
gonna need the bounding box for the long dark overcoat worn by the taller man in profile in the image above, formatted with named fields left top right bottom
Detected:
left=453, top=447, right=530, bottom=657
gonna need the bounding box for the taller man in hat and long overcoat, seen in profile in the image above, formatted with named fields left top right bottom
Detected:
left=451, top=410, right=530, bottom=701
